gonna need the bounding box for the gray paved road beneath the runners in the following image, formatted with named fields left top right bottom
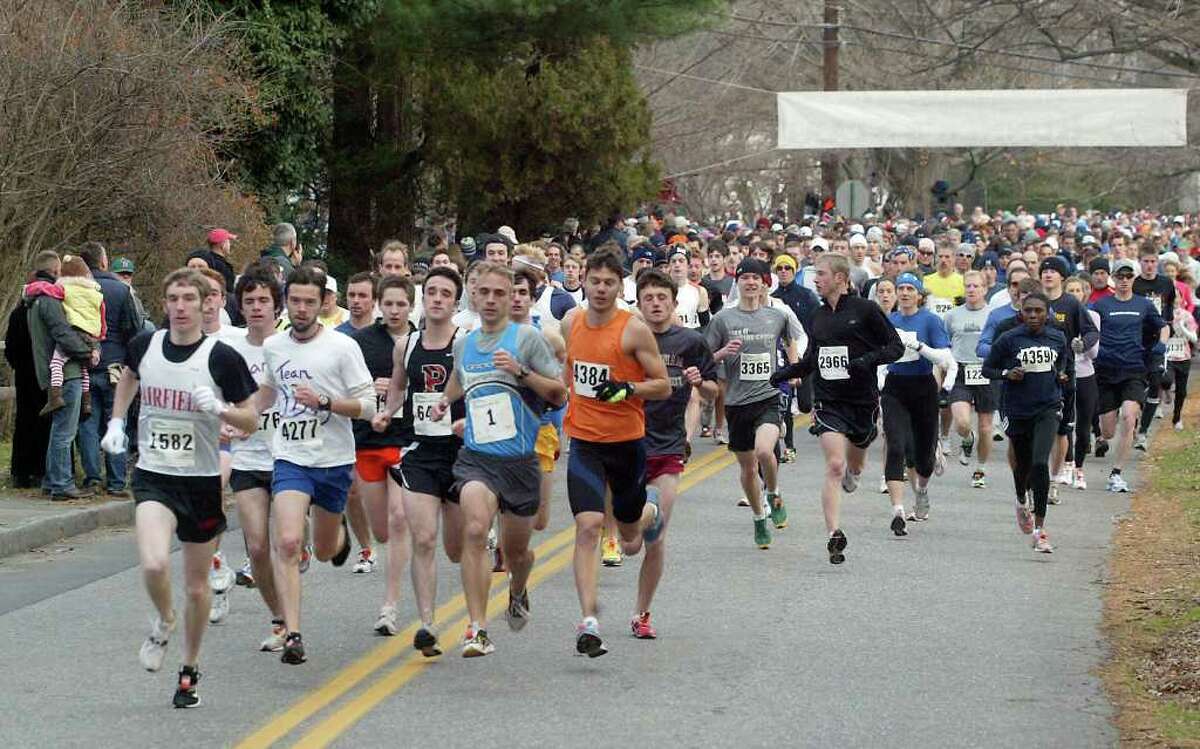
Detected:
left=0, top=430, right=1128, bottom=748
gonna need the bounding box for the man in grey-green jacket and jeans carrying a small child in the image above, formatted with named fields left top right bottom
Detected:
left=24, top=249, right=92, bottom=501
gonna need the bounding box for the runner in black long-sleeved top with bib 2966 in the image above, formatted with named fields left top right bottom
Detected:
left=772, top=254, right=904, bottom=564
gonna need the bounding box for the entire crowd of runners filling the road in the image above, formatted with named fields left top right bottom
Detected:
left=101, top=206, right=1200, bottom=707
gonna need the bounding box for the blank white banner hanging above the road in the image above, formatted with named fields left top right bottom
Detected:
left=776, top=89, right=1188, bottom=150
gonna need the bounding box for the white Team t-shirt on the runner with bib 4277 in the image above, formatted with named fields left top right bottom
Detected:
left=263, top=328, right=374, bottom=468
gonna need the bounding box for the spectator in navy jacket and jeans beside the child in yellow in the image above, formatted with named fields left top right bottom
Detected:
left=79, top=242, right=145, bottom=497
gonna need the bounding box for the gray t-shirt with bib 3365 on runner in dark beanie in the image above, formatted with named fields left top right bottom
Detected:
left=704, top=307, right=803, bottom=406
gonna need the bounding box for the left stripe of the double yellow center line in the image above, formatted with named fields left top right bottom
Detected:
left=235, top=447, right=733, bottom=749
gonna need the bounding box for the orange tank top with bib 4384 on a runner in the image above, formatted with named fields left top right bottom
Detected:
left=563, top=310, right=646, bottom=442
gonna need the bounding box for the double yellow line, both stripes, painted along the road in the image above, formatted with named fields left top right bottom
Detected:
left=236, top=448, right=736, bottom=749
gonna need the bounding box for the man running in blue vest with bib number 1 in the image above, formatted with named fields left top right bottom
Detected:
left=430, top=262, right=570, bottom=658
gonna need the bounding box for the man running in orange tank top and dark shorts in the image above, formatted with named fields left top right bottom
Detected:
left=563, top=248, right=671, bottom=658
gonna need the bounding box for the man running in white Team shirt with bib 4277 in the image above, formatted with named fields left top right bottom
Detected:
left=257, top=265, right=376, bottom=665
